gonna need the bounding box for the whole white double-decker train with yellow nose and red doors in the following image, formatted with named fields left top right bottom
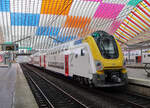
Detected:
left=30, top=31, right=127, bottom=87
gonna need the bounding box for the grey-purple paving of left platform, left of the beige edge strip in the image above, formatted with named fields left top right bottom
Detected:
left=0, top=65, right=17, bottom=108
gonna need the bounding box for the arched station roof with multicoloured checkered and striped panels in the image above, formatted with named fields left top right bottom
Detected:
left=0, top=0, right=150, bottom=50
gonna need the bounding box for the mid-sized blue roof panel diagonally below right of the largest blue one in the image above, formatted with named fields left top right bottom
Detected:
left=36, top=27, right=60, bottom=36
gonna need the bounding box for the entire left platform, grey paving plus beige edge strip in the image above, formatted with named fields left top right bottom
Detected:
left=0, top=63, right=38, bottom=108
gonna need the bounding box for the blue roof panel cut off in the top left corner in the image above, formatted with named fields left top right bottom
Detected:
left=0, top=0, right=10, bottom=12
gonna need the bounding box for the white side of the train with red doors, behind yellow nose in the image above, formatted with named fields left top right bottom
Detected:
left=32, top=43, right=96, bottom=79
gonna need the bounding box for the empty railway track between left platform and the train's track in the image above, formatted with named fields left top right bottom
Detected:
left=22, top=65, right=88, bottom=108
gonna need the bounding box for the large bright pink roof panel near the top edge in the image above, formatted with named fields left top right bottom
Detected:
left=94, top=3, right=125, bottom=19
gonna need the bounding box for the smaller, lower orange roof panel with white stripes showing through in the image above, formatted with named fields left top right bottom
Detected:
left=65, top=16, right=91, bottom=29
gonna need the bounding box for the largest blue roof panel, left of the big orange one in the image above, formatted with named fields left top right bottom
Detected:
left=10, top=13, right=40, bottom=26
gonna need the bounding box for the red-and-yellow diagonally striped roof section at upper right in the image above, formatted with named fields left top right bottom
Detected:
left=114, top=0, right=150, bottom=42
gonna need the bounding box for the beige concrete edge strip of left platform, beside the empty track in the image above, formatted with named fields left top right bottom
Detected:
left=14, top=64, right=38, bottom=108
